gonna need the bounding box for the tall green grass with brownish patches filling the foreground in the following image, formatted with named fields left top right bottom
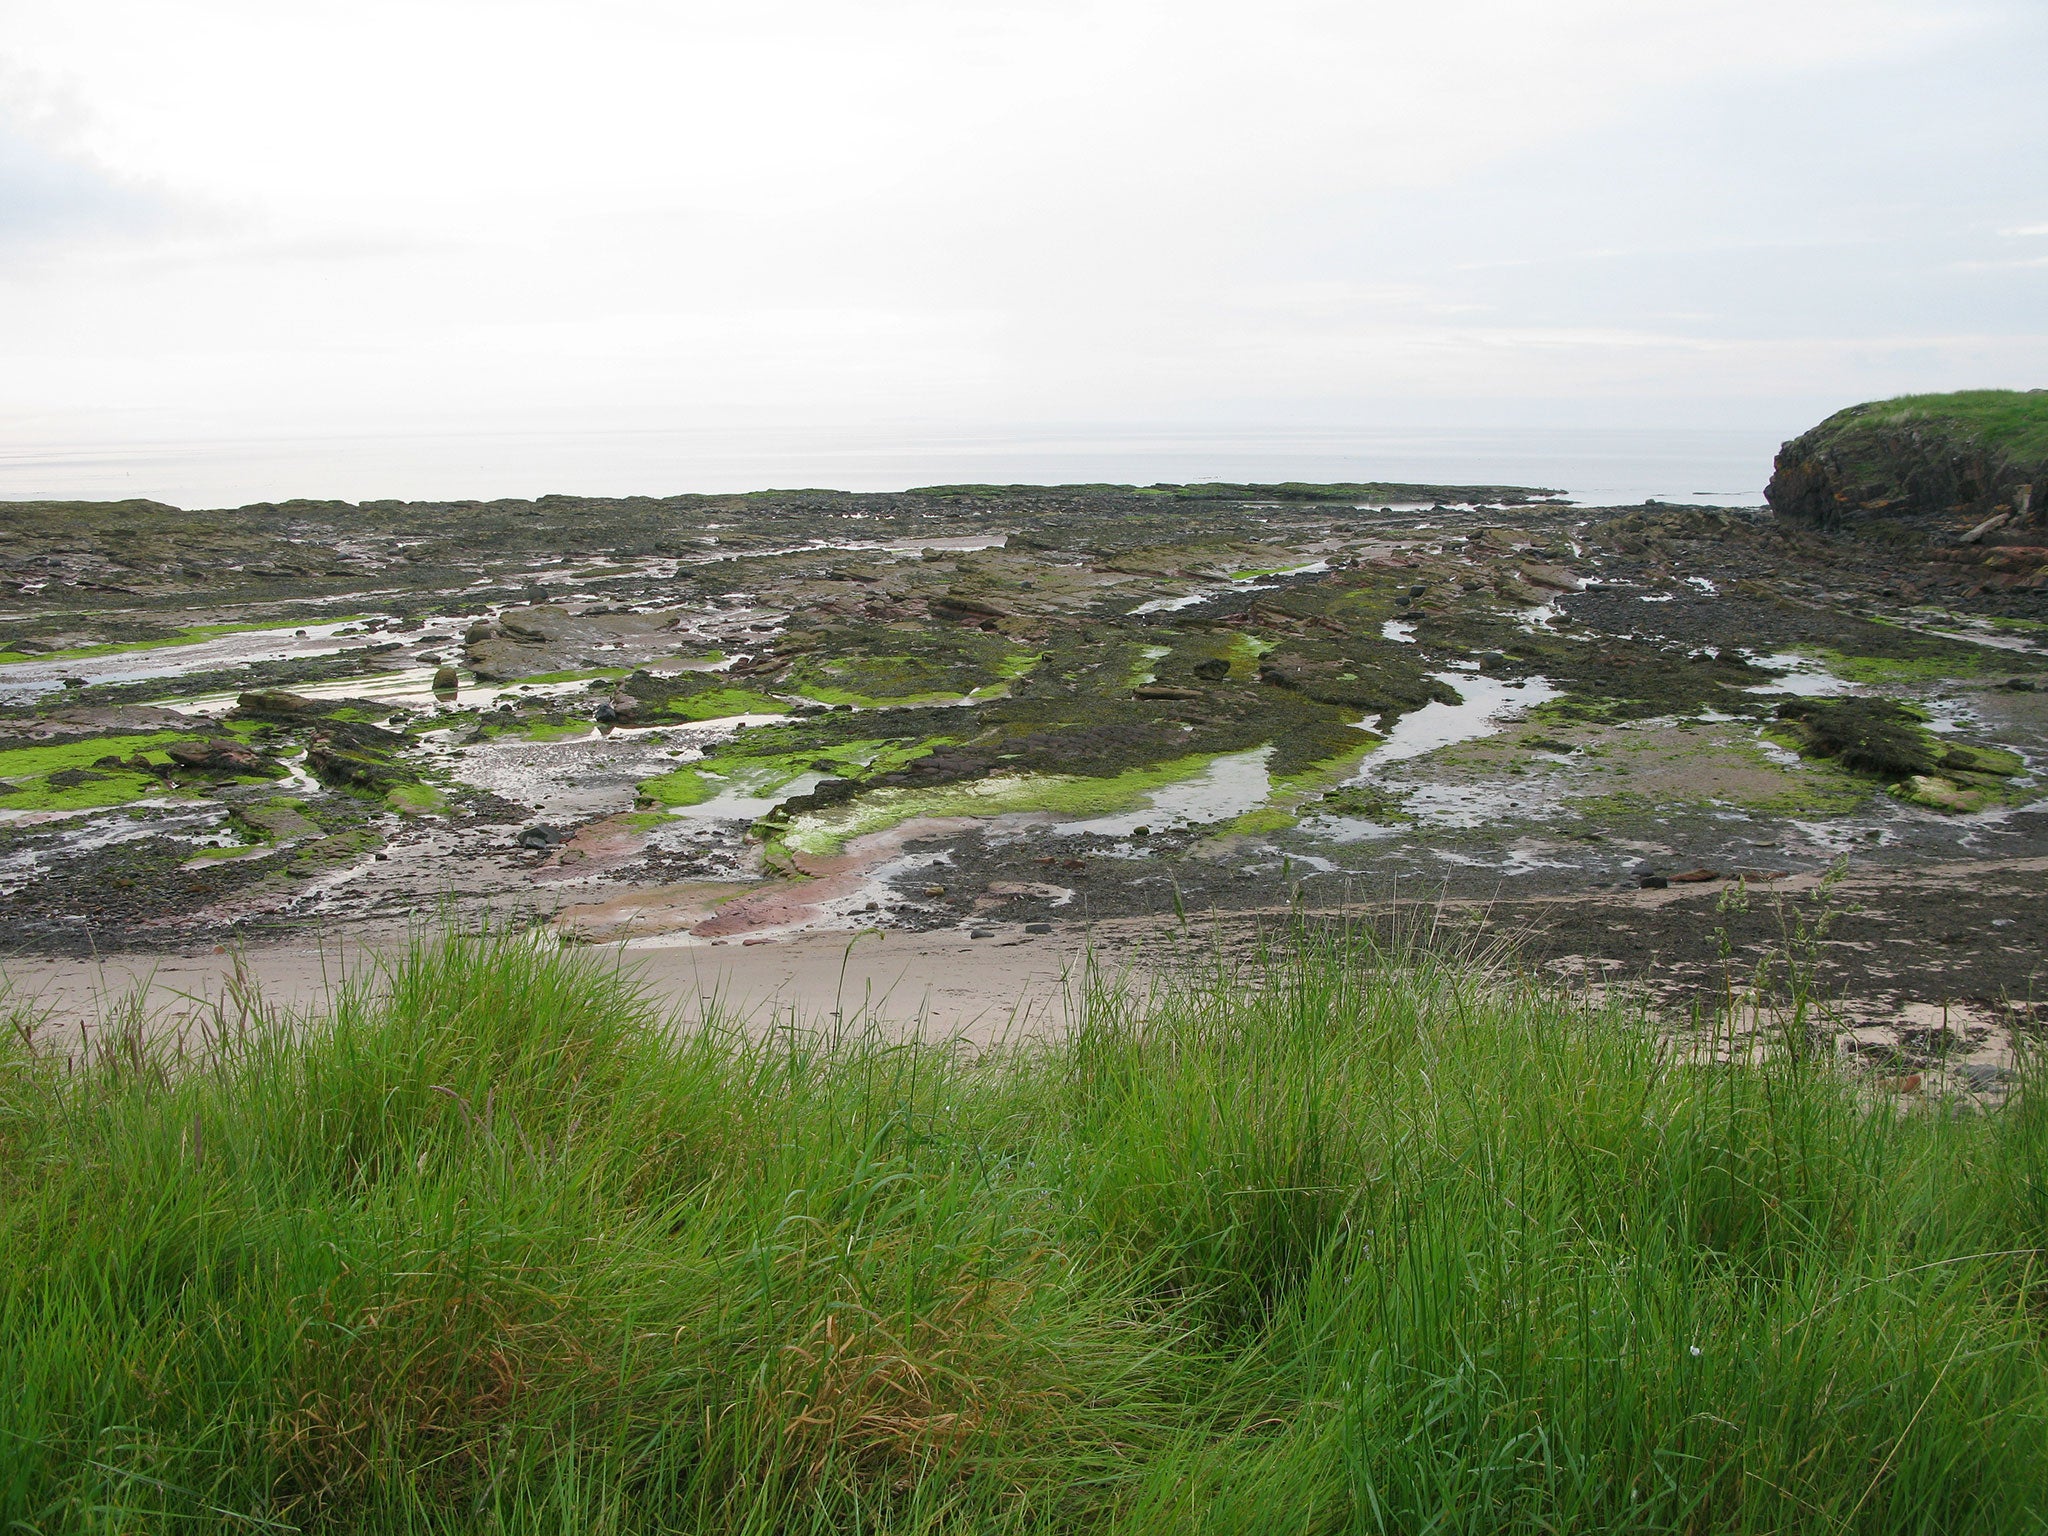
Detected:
left=0, top=936, right=2048, bottom=1534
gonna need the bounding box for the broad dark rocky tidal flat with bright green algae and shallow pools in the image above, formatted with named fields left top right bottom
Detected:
left=0, top=485, right=2048, bottom=952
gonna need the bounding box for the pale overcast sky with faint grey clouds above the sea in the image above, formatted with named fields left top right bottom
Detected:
left=0, top=0, right=2048, bottom=500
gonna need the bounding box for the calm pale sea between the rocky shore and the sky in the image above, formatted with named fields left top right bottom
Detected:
left=0, top=428, right=1782, bottom=508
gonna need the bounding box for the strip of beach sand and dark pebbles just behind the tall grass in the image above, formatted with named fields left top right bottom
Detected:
left=12, top=858, right=2048, bottom=1073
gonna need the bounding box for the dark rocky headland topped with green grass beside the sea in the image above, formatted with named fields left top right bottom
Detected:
left=1765, top=389, right=2048, bottom=526
